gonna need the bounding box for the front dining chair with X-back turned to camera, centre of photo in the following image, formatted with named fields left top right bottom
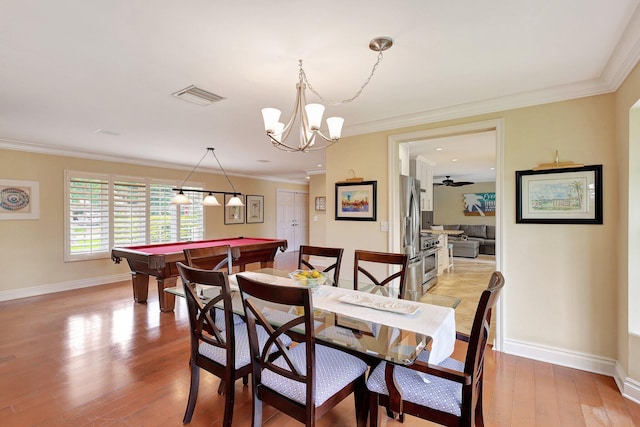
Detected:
left=238, top=277, right=368, bottom=427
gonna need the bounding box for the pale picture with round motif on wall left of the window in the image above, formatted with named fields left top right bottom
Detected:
left=0, top=179, right=40, bottom=220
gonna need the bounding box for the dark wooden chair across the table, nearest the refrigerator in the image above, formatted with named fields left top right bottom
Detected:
left=353, top=249, right=409, bottom=298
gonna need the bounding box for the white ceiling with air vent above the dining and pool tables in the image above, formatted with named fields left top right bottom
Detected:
left=0, top=0, right=640, bottom=179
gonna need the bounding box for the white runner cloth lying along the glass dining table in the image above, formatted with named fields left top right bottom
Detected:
left=229, top=272, right=456, bottom=364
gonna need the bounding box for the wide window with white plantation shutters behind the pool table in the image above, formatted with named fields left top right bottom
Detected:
left=65, top=171, right=204, bottom=261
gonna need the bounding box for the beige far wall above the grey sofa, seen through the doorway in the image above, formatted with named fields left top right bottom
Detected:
left=433, top=182, right=496, bottom=225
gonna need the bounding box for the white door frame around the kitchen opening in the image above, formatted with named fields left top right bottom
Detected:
left=388, top=119, right=507, bottom=351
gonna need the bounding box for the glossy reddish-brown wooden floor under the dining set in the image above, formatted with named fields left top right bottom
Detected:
left=0, top=252, right=640, bottom=427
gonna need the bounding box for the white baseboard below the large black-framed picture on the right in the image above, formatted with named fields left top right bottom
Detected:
left=503, top=339, right=617, bottom=381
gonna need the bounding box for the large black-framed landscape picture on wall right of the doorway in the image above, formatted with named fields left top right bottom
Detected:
left=516, top=165, right=602, bottom=224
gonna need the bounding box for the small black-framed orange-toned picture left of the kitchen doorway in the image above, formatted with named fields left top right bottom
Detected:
left=336, top=181, right=378, bottom=221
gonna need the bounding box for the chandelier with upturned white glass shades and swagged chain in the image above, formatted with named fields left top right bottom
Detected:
left=262, top=37, right=393, bottom=152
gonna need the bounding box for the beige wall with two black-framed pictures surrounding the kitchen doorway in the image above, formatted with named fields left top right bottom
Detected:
left=327, top=95, right=618, bottom=368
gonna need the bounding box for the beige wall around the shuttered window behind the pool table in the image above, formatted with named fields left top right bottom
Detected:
left=0, top=150, right=307, bottom=292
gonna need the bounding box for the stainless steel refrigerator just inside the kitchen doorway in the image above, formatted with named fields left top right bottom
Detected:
left=400, top=175, right=423, bottom=300
